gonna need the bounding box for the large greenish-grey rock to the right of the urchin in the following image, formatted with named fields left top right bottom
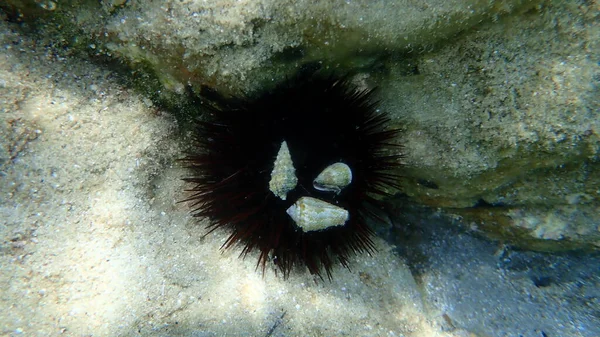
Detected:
left=380, top=1, right=600, bottom=250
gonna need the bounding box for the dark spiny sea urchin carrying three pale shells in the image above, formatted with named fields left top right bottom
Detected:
left=184, top=70, right=401, bottom=279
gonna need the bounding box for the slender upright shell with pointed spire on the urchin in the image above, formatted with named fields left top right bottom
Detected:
left=269, top=141, right=298, bottom=200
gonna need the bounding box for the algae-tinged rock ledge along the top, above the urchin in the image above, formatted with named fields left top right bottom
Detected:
left=5, top=0, right=539, bottom=93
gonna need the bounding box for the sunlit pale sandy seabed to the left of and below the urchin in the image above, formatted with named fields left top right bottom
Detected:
left=0, top=23, right=468, bottom=336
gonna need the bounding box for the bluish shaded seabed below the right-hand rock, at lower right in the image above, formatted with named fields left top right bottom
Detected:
left=379, top=196, right=600, bottom=337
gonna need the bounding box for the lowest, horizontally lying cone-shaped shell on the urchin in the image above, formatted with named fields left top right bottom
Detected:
left=286, top=197, right=349, bottom=232
